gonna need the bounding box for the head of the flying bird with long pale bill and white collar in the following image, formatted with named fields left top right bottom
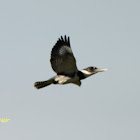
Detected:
left=81, top=67, right=107, bottom=77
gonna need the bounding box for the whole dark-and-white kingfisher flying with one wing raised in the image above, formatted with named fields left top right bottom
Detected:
left=34, top=35, right=107, bottom=89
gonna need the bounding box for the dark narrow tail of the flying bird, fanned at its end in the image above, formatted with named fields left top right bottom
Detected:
left=34, top=79, right=54, bottom=89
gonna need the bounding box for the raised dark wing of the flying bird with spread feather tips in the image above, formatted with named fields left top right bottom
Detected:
left=50, top=36, right=78, bottom=75
